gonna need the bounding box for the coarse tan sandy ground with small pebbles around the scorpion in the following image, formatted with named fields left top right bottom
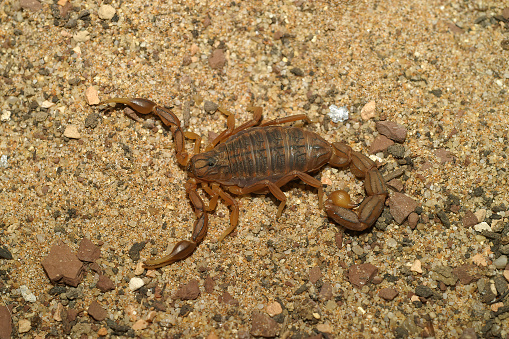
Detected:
left=0, top=0, right=509, bottom=338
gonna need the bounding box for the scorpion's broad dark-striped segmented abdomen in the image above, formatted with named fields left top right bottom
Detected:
left=218, top=126, right=332, bottom=187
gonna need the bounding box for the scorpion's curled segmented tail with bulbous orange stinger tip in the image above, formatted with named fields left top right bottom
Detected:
left=325, top=143, right=388, bottom=231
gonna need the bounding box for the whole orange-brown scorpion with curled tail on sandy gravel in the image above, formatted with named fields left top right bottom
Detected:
left=104, top=98, right=388, bottom=269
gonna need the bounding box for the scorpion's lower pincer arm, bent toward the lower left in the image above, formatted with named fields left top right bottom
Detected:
left=143, top=179, right=209, bottom=269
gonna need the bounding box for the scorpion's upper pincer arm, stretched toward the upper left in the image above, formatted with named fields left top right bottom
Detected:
left=103, top=98, right=189, bottom=166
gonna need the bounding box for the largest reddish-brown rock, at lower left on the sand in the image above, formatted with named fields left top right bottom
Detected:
left=42, top=242, right=83, bottom=287
